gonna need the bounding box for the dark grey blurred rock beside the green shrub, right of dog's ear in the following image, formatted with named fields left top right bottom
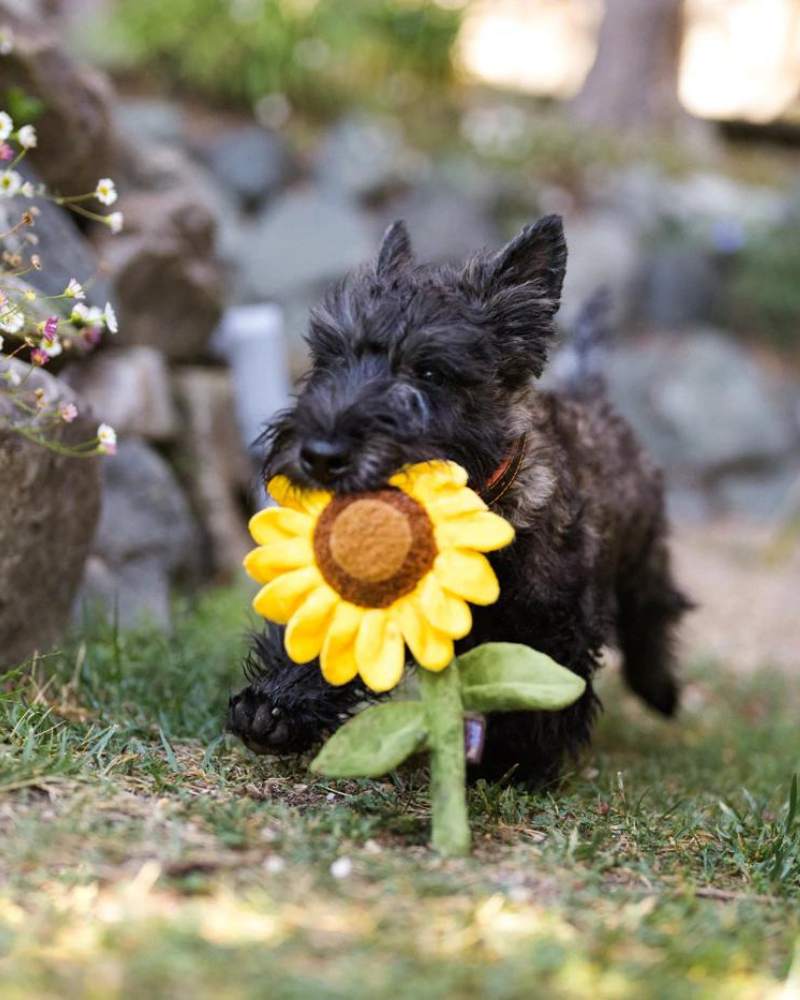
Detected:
left=636, top=241, right=723, bottom=330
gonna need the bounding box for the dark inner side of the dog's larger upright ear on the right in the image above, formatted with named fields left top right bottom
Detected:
left=491, top=215, right=567, bottom=316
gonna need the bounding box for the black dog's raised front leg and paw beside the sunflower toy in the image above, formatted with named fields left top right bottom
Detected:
left=226, top=626, right=375, bottom=754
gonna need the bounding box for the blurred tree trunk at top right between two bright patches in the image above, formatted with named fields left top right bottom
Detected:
left=573, top=0, right=685, bottom=132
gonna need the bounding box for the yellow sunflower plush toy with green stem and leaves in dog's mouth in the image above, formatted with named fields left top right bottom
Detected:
left=245, top=461, right=584, bottom=855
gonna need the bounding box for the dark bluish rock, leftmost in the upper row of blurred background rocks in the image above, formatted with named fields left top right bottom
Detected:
left=199, top=125, right=295, bottom=209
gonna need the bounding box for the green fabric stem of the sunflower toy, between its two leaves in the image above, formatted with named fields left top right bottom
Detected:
left=419, top=660, right=470, bottom=858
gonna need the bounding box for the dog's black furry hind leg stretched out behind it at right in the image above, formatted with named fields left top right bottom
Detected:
left=617, top=532, right=692, bottom=716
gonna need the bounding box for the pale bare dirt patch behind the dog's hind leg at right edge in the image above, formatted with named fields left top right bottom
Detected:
left=673, top=520, right=800, bottom=673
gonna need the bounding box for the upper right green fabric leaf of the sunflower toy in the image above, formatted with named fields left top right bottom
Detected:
left=458, top=642, right=586, bottom=712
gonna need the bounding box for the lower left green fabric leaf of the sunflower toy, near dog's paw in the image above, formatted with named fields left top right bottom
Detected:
left=311, top=701, right=428, bottom=778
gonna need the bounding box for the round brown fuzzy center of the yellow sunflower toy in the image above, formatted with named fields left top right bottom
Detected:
left=314, top=489, right=437, bottom=608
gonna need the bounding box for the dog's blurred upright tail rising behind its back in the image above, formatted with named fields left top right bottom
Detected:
left=556, top=285, right=612, bottom=397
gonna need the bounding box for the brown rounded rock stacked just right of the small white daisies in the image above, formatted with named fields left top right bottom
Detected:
left=105, top=191, right=222, bottom=361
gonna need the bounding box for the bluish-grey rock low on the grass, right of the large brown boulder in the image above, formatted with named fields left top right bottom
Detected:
left=81, top=440, right=203, bottom=626
